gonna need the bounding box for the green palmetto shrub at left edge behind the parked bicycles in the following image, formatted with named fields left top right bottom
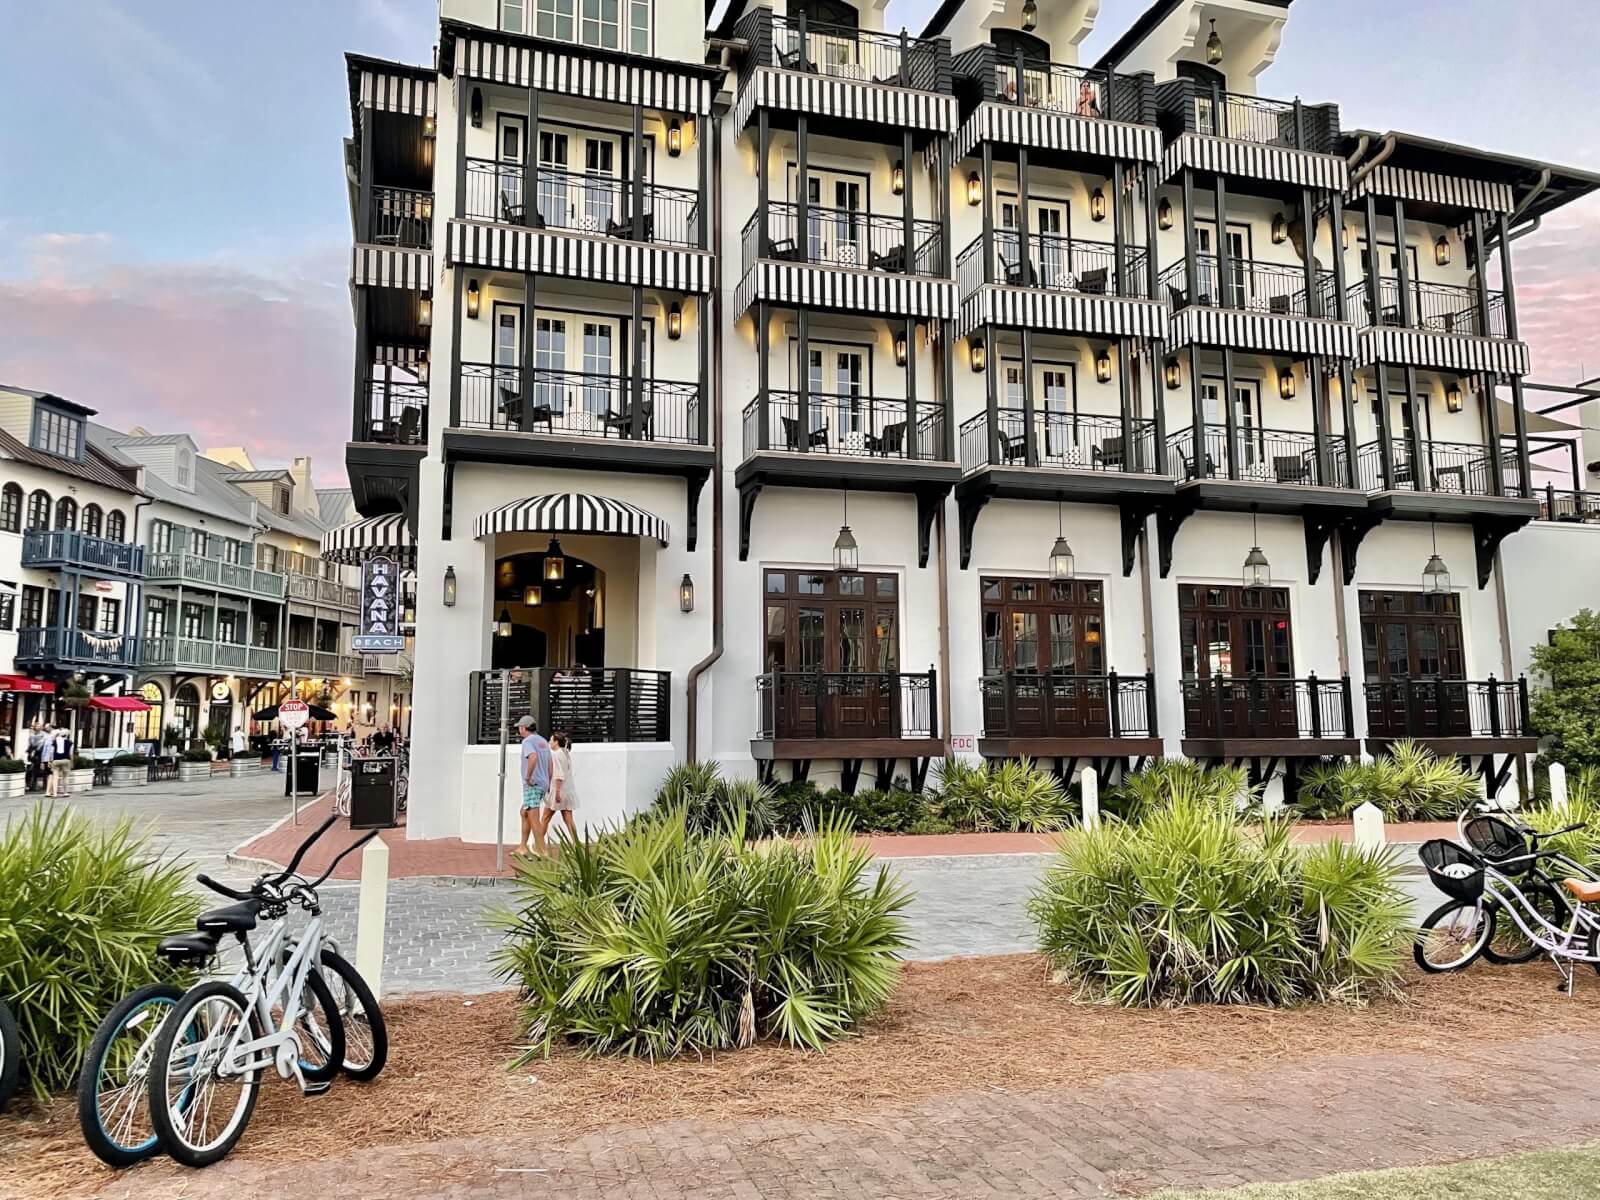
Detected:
left=0, top=805, right=200, bottom=1096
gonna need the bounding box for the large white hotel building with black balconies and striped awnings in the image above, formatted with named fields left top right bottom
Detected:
left=337, top=0, right=1600, bottom=840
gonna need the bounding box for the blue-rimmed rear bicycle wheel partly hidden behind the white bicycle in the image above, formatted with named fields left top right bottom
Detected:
left=78, top=984, right=184, bottom=1166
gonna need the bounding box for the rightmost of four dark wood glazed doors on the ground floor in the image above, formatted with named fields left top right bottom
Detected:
left=1362, top=592, right=1472, bottom=738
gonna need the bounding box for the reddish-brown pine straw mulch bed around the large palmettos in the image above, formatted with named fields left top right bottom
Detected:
left=9, top=954, right=1600, bottom=1197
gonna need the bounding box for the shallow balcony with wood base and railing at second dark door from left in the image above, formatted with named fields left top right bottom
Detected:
left=978, top=670, right=1162, bottom=764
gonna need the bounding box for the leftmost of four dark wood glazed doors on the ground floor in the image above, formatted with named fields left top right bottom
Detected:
left=763, top=571, right=899, bottom=739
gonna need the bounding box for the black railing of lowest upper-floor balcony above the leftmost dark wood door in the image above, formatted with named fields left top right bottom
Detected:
left=744, top=392, right=944, bottom=461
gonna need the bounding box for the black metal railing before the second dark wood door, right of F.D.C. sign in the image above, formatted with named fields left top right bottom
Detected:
left=978, top=670, right=1160, bottom=738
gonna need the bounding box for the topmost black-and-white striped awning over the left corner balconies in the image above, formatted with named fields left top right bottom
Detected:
left=456, top=37, right=716, bottom=115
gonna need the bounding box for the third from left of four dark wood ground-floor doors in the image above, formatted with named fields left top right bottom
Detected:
left=1178, top=584, right=1315, bottom=738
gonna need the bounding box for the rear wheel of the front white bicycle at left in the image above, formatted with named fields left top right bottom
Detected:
left=150, top=981, right=266, bottom=1166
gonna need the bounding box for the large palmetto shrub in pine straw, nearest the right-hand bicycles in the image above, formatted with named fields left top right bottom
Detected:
left=1029, top=789, right=1410, bottom=1006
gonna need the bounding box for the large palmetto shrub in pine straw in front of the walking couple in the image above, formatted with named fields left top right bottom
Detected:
left=494, top=808, right=909, bottom=1058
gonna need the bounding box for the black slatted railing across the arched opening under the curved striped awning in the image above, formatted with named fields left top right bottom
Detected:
left=467, top=667, right=672, bottom=746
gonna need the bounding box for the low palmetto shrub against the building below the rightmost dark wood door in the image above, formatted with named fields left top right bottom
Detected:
left=1299, top=741, right=1478, bottom=821
